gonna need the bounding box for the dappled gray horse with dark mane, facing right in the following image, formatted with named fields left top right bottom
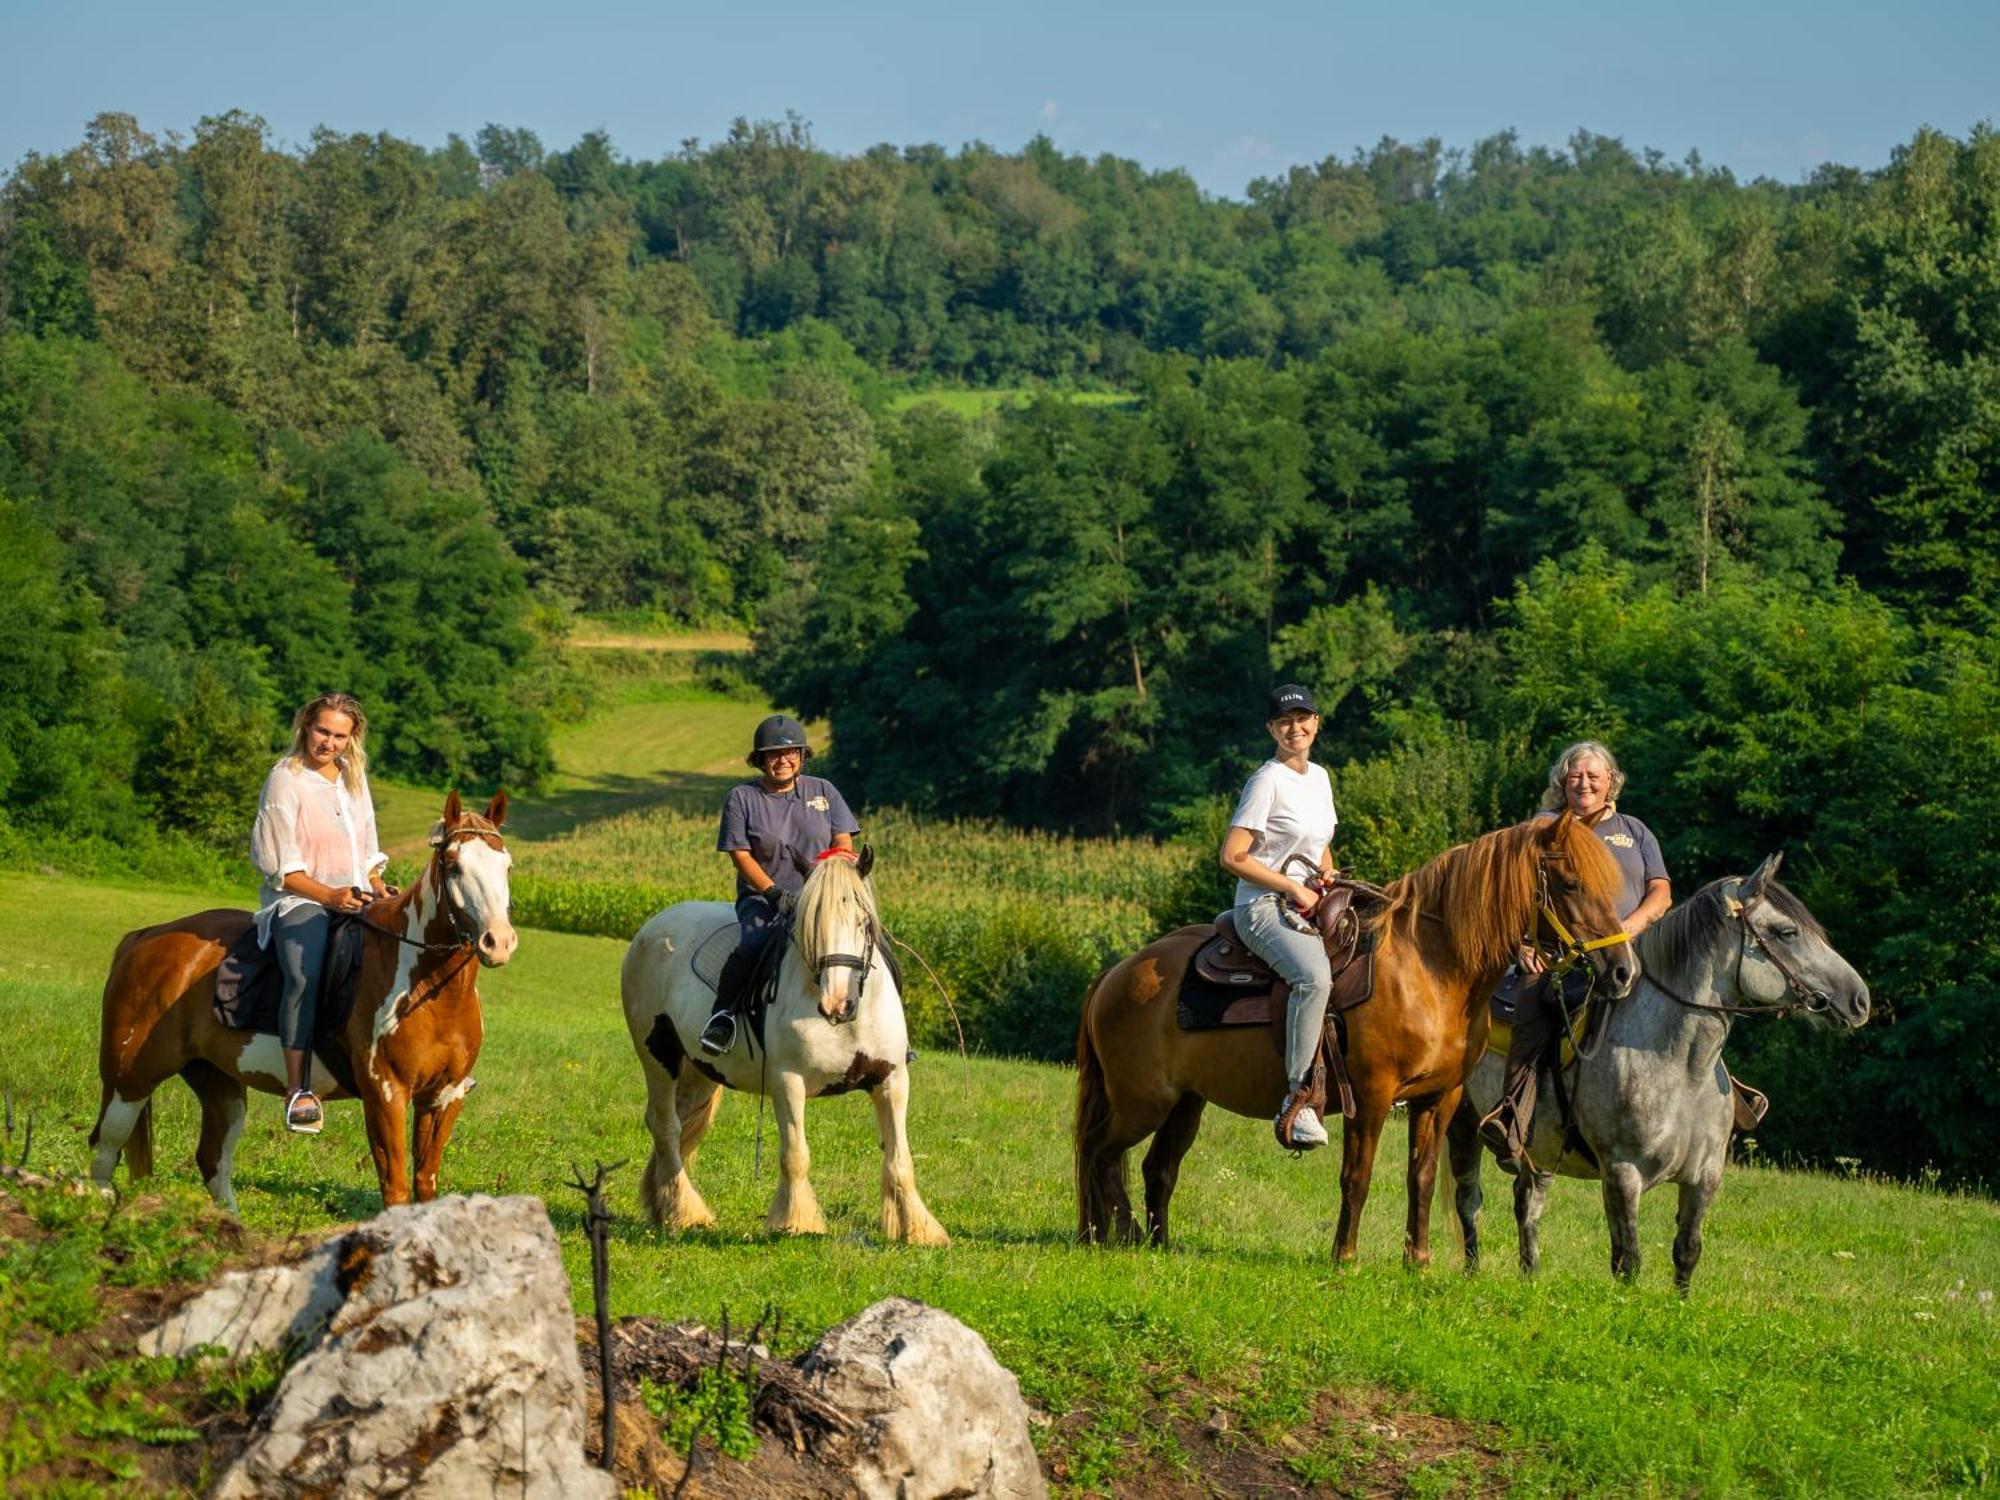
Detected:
left=1450, top=854, right=1868, bottom=1292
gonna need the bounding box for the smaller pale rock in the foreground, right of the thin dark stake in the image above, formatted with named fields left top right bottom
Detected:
left=800, top=1298, right=1048, bottom=1500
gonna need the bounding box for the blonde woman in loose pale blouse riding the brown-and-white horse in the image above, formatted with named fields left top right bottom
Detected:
left=250, top=692, right=394, bottom=1136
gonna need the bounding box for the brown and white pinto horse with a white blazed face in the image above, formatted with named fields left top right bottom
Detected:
left=90, top=792, right=516, bottom=1214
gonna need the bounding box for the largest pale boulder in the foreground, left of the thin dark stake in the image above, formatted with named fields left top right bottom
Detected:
left=212, top=1196, right=616, bottom=1500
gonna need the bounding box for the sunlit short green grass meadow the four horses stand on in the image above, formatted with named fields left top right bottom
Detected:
left=0, top=876, right=2000, bottom=1494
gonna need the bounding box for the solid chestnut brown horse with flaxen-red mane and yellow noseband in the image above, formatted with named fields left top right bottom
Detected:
left=1076, top=812, right=1638, bottom=1266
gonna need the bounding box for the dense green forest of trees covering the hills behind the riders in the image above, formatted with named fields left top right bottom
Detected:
left=0, top=114, right=2000, bottom=1178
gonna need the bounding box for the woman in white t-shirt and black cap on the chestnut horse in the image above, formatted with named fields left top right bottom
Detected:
left=1220, top=682, right=1338, bottom=1150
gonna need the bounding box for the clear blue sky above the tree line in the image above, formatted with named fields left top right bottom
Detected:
left=0, top=0, right=2000, bottom=196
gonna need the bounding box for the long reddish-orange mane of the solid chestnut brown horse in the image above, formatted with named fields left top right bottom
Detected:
left=1374, top=818, right=1624, bottom=974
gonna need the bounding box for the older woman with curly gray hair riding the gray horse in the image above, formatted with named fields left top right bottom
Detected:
left=1480, top=740, right=1674, bottom=1166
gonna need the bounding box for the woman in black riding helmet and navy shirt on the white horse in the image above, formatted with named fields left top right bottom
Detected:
left=702, top=714, right=860, bottom=1056
